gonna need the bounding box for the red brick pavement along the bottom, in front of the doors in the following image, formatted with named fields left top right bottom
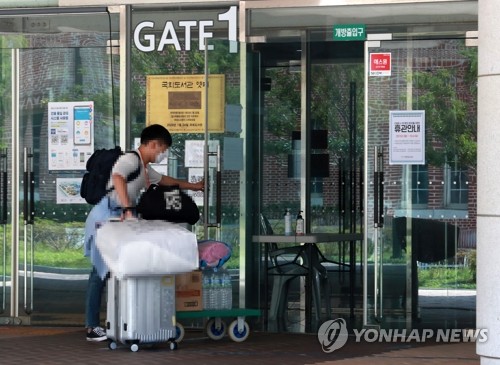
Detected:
left=0, top=326, right=479, bottom=365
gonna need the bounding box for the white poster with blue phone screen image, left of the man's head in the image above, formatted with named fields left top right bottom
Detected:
left=48, top=101, right=94, bottom=171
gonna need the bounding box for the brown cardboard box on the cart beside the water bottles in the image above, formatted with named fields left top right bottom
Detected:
left=175, top=270, right=203, bottom=312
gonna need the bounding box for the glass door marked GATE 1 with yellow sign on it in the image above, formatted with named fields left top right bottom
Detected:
left=130, top=6, right=246, bottom=316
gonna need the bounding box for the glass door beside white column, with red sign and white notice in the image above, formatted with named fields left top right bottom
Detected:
left=363, top=35, right=477, bottom=328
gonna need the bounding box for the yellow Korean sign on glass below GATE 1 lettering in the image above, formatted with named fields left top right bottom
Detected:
left=146, top=75, right=225, bottom=133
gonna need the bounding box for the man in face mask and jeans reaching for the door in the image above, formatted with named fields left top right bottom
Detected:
left=85, top=124, right=204, bottom=341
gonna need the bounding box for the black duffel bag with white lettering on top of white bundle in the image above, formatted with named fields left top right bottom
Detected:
left=137, top=184, right=200, bottom=224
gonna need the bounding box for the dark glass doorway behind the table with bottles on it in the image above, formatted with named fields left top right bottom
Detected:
left=252, top=31, right=364, bottom=332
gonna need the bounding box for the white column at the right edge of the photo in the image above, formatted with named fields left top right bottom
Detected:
left=476, top=0, right=500, bottom=365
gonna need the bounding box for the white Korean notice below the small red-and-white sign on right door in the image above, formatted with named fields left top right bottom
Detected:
left=389, top=110, right=425, bottom=165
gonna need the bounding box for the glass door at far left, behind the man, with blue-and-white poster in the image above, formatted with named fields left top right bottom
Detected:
left=0, top=9, right=118, bottom=325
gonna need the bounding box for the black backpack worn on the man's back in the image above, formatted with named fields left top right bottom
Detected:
left=80, top=146, right=141, bottom=205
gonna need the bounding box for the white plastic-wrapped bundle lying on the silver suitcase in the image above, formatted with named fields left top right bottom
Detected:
left=96, top=219, right=199, bottom=278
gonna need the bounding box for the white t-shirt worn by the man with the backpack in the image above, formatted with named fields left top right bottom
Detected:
left=108, top=150, right=162, bottom=206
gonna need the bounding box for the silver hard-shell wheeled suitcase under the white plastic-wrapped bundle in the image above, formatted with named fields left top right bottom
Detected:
left=106, top=275, right=177, bottom=352
